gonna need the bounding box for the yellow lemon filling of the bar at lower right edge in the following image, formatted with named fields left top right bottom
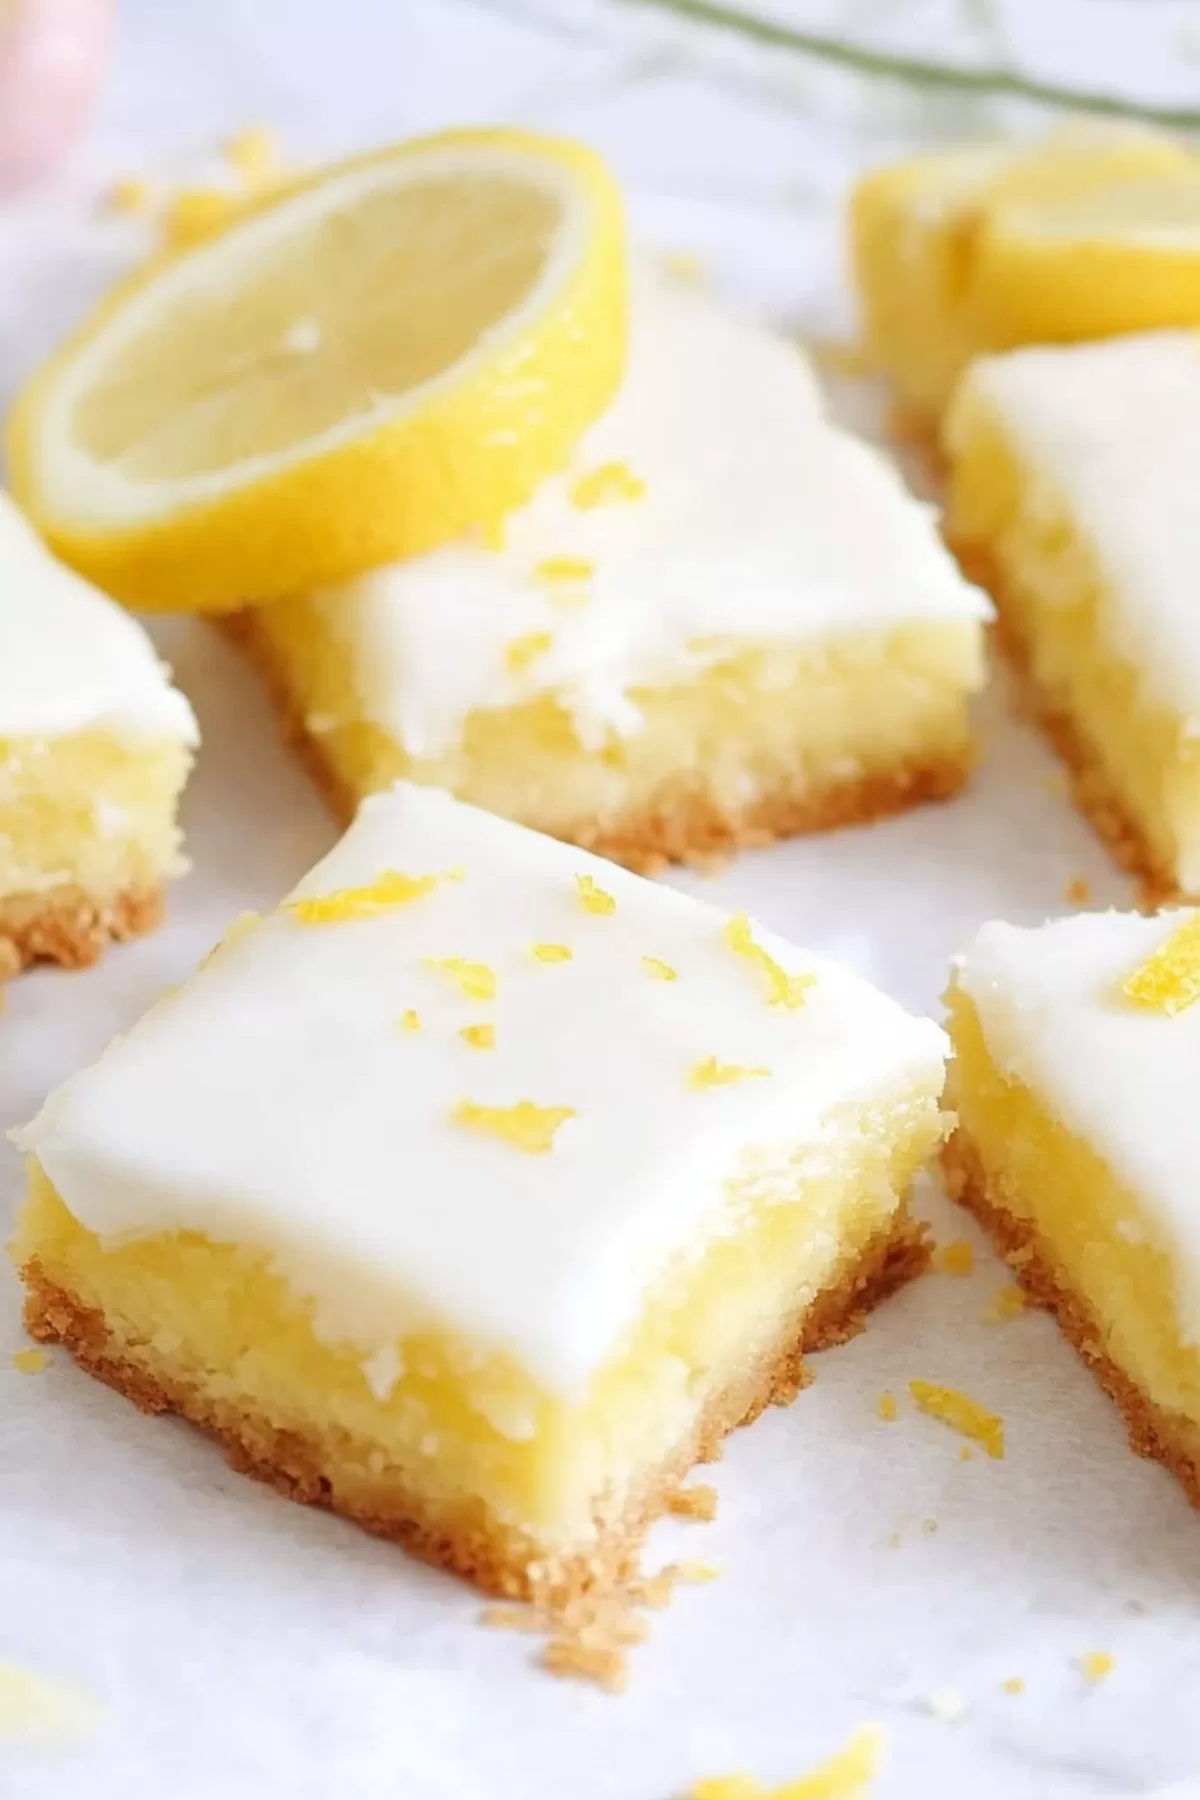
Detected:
left=948, top=988, right=1200, bottom=1422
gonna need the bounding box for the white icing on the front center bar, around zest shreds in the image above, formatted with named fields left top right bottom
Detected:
left=20, top=785, right=945, bottom=1391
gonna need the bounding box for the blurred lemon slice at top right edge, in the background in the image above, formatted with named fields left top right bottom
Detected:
left=973, top=166, right=1200, bottom=346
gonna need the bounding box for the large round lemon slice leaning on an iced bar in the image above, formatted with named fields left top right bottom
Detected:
left=9, top=130, right=626, bottom=612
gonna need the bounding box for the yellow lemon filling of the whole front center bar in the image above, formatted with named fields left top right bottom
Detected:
left=13, top=1085, right=941, bottom=1553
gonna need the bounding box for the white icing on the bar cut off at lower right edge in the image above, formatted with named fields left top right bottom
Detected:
left=957, top=911, right=1200, bottom=1343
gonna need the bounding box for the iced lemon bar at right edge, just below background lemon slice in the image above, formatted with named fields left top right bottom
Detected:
left=945, top=331, right=1200, bottom=896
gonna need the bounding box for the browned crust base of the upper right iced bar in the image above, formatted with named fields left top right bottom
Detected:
left=946, top=531, right=1180, bottom=907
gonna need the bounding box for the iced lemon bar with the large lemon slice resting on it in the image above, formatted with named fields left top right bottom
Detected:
left=239, top=272, right=986, bottom=869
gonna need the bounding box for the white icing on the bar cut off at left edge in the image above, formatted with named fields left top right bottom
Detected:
left=0, top=493, right=196, bottom=743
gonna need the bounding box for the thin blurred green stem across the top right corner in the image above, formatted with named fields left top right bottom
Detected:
left=622, top=0, right=1200, bottom=131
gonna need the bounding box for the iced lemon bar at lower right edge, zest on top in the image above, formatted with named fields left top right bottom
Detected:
left=943, top=911, right=1200, bottom=1503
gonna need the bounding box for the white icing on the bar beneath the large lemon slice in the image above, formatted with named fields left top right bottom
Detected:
left=300, top=270, right=988, bottom=756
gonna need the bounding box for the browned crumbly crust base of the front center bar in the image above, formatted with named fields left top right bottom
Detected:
left=22, top=1208, right=928, bottom=1606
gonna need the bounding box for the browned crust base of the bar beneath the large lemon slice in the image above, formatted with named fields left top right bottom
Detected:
left=212, top=614, right=975, bottom=875
